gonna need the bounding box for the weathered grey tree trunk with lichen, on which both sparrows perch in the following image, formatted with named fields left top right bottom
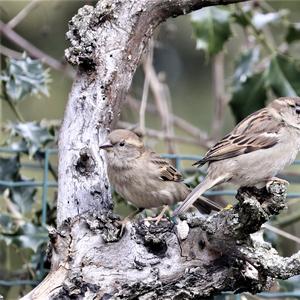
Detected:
left=19, top=0, right=300, bottom=300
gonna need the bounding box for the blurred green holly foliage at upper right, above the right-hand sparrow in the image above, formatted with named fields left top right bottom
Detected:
left=192, top=5, right=300, bottom=122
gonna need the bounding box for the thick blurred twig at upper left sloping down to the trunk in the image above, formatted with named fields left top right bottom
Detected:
left=0, top=20, right=75, bottom=78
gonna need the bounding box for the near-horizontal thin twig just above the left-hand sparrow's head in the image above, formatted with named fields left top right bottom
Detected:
left=118, top=121, right=201, bottom=146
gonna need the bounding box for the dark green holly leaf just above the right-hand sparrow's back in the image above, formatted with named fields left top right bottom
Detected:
left=229, top=73, right=267, bottom=122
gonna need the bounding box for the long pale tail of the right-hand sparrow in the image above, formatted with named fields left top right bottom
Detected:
left=173, top=176, right=225, bottom=217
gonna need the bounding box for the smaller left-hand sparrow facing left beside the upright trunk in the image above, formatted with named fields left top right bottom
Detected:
left=100, top=129, right=221, bottom=223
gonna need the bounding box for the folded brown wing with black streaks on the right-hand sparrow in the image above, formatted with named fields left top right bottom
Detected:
left=195, top=108, right=284, bottom=166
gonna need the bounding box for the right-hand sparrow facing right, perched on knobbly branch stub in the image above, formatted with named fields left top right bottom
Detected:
left=174, top=97, right=300, bottom=216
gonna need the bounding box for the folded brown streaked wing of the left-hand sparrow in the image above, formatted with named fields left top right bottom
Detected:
left=146, top=151, right=183, bottom=182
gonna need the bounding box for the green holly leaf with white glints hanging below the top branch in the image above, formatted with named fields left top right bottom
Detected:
left=192, top=7, right=232, bottom=55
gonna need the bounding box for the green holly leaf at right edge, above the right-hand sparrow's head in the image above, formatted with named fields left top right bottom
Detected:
left=266, top=55, right=300, bottom=97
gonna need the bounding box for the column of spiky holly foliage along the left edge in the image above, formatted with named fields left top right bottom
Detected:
left=0, top=54, right=56, bottom=298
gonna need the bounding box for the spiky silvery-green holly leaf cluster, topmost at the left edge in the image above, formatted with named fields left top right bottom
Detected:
left=0, top=54, right=50, bottom=103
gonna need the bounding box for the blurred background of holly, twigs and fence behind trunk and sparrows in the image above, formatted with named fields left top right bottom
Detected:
left=0, top=0, right=300, bottom=299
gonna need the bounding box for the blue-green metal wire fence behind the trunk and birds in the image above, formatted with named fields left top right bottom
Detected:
left=0, top=147, right=300, bottom=300
